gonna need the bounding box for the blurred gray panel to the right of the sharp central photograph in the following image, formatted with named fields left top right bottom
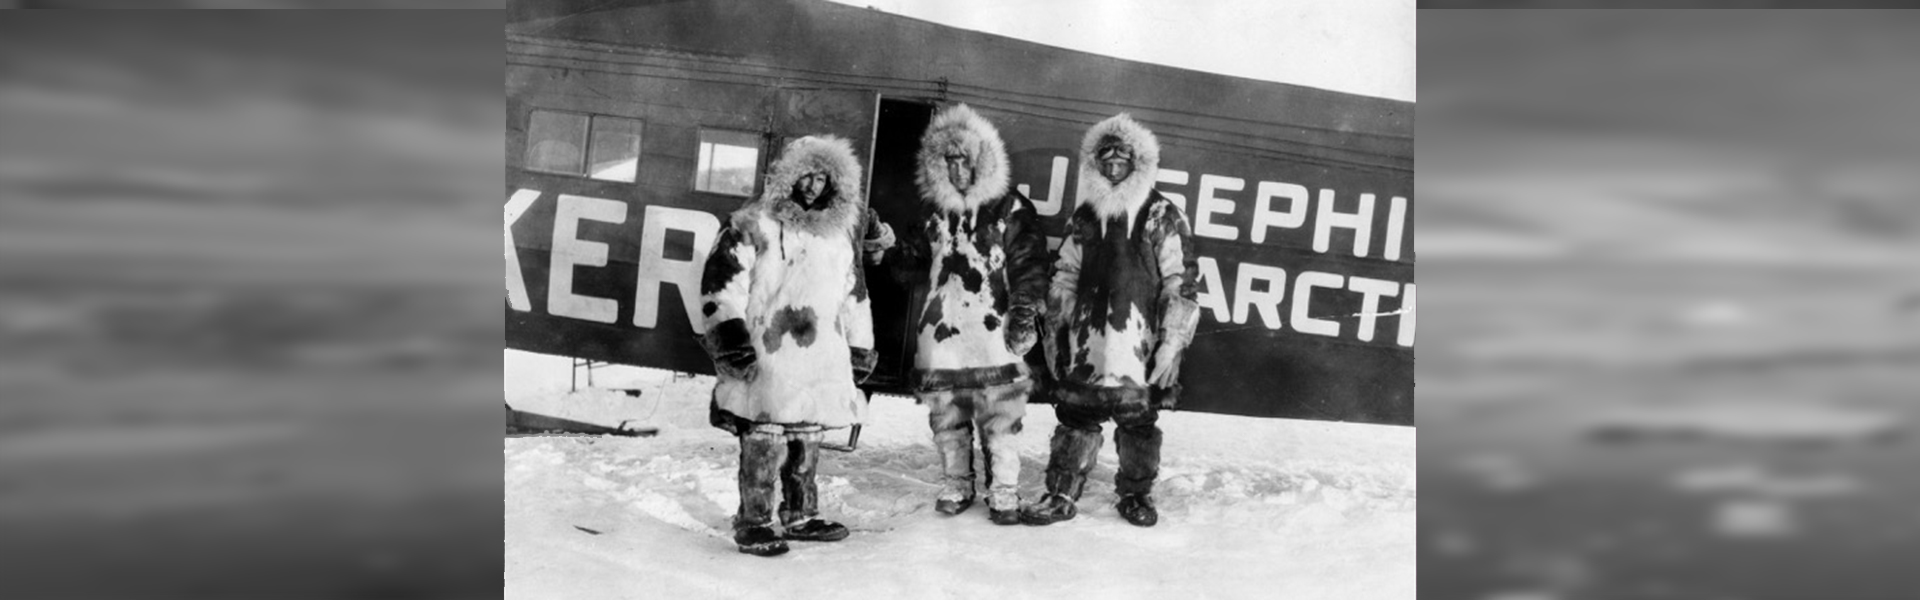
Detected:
left=1417, top=9, right=1920, bottom=598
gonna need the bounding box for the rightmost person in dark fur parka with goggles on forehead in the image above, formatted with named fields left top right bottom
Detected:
left=1021, top=113, right=1200, bottom=527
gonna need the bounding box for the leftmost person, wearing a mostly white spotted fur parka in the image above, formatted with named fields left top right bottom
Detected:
left=701, top=137, right=874, bottom=556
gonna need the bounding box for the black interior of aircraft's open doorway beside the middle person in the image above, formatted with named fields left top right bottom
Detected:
left=866, top=98, right=933, bottom=390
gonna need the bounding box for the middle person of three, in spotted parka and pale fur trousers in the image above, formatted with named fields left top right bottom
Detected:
left=902, top=104, right=1048, bottom=525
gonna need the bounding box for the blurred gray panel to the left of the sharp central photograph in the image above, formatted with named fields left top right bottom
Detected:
left=0, top=10, right=505, bottom=598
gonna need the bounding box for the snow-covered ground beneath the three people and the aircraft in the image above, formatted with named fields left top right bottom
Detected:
left=505, top=350, right=1417, bottom=598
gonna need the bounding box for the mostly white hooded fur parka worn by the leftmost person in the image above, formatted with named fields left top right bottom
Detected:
left=701, top=137, right=874, bottom=435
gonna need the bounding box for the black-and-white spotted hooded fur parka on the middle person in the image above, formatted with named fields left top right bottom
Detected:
left=908, top=104, right=1048, bottom=392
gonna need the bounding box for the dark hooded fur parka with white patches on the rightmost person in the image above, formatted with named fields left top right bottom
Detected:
left=1044, top=115, right=1200, bottom=408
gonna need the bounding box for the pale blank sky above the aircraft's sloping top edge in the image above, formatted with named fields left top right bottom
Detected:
left=833, top=0, right=1415, bottom=102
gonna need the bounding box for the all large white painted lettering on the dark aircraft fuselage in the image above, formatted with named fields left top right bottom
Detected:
left=505, top=156, right=1415, bottom=348
